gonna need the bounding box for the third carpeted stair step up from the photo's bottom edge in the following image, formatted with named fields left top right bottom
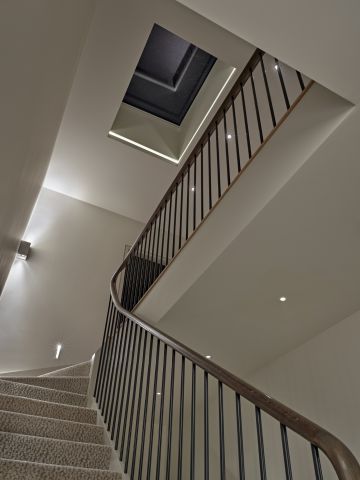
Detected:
left=0, top=411, right=104, bottom=444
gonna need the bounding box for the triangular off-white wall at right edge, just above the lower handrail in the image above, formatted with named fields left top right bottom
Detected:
left=247, top=311, right=360, bottom=480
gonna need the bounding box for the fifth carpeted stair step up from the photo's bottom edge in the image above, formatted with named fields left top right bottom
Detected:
left=0, top=377, right=88, bottom=407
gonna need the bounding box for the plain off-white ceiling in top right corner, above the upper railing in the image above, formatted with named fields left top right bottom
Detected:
left=179, top=0, right=360, bottom=103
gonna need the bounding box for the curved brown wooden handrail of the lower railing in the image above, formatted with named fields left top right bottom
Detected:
left=110, top=266, right=360, bottom=480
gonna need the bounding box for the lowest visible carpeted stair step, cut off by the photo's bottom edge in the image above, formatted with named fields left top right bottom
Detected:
left=0, top=458, right=121, bottom=480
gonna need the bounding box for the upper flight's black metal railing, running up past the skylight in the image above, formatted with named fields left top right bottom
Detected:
left=121, top=50, right=312, bottom=310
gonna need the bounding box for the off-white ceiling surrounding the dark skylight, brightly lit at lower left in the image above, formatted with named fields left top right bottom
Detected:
left=44, top=0, right=254, bottom=222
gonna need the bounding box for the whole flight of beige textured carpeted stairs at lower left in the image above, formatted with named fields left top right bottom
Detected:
left=0, top=362, right=121, bottom=480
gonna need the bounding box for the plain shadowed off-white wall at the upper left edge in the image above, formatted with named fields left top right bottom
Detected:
left=0, top=0, right=94, bottom=293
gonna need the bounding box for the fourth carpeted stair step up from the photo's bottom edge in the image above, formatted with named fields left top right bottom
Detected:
left=0, top=393, right=97, bottom=424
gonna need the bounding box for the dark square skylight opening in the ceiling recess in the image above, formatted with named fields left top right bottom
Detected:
left=123, top=24, right=216, bottom=125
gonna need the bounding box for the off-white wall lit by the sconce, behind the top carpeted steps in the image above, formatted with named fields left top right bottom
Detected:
left=0, top=189, right=143, bottom=372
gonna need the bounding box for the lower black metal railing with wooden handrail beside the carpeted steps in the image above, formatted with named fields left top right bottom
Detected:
left=95, top=284, right=360, bottom=480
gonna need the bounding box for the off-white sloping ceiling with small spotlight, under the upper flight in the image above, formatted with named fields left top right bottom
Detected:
left=158, top=96, right=360, bottom=375
